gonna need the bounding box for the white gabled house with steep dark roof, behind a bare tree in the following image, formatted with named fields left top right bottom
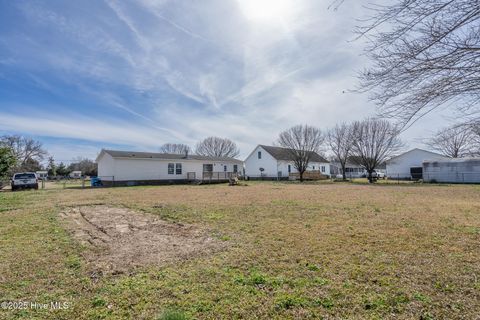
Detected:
left=244, top=145, right=330, bottom=179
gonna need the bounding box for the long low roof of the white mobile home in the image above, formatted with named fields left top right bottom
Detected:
left=97, top=149, right=242, bottom=163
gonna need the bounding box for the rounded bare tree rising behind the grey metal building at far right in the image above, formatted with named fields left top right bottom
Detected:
left=427, top=125, right=474, bottom=158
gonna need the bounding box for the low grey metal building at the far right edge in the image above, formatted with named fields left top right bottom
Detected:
left=423, top=158, right=480, bottom=183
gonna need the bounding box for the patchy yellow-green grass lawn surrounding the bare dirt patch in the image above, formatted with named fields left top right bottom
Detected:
left=0, top=182, right=480, bottom=319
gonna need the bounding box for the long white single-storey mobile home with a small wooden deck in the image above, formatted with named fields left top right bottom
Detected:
left=96, top=149, right=242, bottom=185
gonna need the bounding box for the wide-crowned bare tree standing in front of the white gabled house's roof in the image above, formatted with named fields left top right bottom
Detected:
left=278, top=125, right=325, bottom=182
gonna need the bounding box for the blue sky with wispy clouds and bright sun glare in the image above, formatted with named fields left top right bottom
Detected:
left=0, top=0, right=447, bottom=160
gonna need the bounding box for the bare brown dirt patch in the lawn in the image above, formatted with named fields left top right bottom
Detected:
left=62, top=206, right=222, bottom=272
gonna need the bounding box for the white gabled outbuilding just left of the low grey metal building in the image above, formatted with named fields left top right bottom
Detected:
left=387, top=148, right=448, bottom=179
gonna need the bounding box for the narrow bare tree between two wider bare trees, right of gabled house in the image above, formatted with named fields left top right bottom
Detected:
left=327, top=123, right=353, bottom=180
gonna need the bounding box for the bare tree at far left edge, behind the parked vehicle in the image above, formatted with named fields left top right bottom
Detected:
left=0, top=135, right=47, bottom=169
